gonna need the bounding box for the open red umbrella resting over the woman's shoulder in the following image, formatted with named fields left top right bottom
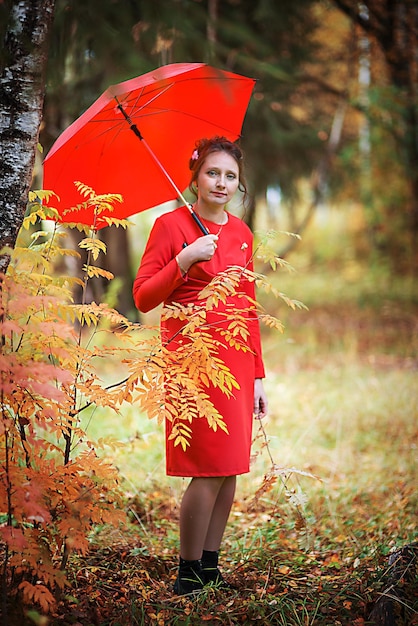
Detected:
left=43, top=63, right=255, bottom=228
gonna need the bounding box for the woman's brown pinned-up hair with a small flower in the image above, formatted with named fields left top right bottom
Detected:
left=189, top=137, right=248, bottom=199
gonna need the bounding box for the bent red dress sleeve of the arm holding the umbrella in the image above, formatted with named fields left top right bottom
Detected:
left=133, top=219, right=185, bottom=313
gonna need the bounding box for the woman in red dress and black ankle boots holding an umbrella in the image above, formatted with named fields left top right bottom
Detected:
left=133, top=137, right=267, bottom=594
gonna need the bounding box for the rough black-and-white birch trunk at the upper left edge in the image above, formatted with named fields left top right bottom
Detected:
left=0, top=0, right=55, bottom=272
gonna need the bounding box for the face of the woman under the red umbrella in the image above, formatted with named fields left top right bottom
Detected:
left=196, top=151, right=239, bottom=208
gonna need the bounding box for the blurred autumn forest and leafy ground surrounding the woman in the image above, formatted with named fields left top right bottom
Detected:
left=0, top=0, right=418, bottom=624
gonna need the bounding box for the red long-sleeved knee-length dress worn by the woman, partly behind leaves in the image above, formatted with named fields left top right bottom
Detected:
left=133, top=207, right=264, bottom=476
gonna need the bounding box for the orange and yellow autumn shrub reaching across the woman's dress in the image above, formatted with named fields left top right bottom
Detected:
left=0, top=184, right=304, bottom=611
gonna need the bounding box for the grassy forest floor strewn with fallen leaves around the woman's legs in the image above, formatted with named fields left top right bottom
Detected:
left=4, top=236, right=418, bottom=626
